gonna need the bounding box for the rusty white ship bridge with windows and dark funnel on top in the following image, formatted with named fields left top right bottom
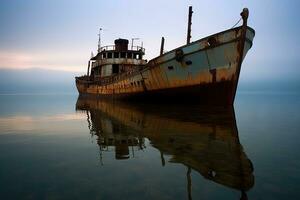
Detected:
left=89, top=38, right=147, bottom=78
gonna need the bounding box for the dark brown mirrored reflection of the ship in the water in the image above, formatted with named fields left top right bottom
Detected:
left=76, top=97, right=254, bottom=199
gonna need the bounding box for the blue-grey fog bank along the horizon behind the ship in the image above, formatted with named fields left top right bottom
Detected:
left=0, top=66, right=300, bottom=94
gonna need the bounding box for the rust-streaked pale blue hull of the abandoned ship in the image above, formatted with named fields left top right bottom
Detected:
left=76, top=9, right=255, bottom=105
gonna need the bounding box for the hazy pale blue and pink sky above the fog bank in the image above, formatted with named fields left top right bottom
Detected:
left=0, top=0, right=300, bottom=80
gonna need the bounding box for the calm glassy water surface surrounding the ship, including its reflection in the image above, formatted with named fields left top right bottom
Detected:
left=0, top=93, right=300, bottom=199
